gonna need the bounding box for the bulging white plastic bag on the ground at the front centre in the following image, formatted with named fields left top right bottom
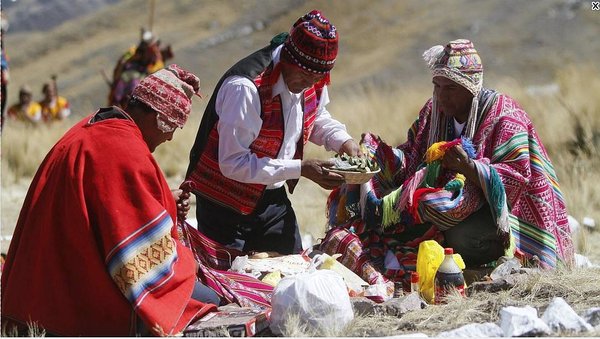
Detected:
left=270, top=270, right=354, bottom=335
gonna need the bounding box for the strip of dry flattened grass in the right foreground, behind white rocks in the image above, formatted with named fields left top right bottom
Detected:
left=276, top=269, right=600, bottom=337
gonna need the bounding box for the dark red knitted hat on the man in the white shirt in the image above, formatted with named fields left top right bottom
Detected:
left=283, top=10, right=338, bottom=73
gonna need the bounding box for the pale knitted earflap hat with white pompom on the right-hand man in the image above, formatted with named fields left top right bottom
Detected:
left=423, top=39, right=483, bottom=145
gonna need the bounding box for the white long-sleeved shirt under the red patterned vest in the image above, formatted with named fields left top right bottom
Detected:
left=215, top=46, right=351, bottom=189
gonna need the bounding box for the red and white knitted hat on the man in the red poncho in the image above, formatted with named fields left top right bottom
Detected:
left=132, top=65, right=200, bottom=128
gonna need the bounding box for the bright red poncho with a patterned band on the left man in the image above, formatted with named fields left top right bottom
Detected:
left=2, top=111, right=215, bottom=336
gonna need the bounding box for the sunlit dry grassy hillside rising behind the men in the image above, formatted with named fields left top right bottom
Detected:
left=2, top=0, right=600, bottom=256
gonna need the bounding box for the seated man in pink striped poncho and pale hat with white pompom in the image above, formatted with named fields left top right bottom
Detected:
left=321, top=40, right=573, bottom=292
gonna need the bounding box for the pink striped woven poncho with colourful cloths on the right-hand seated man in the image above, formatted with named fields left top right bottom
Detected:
left=321, top=90, right=573, bottom=288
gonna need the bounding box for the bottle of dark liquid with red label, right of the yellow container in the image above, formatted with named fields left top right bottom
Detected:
left=434, top=248, right=465, bottom=304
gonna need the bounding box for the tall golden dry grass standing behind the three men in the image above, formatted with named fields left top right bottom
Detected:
left=2, top=66, right=600, bottom=255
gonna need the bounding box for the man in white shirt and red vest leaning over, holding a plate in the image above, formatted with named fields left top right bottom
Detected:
left=182, top=10, right=360, bottom=254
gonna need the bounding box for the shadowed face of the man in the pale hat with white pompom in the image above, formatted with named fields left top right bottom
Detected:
left=432, top=76, right=473, bottom=123
